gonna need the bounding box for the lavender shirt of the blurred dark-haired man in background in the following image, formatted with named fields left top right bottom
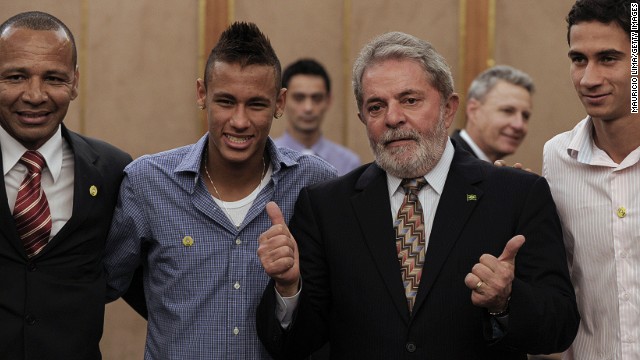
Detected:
left=273, top=131, right=360, bottom=175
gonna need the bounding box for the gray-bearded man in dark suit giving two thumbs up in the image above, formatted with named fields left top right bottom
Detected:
left=257, top=32, right=579, bottom=360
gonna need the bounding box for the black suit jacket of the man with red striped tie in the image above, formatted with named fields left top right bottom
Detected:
left=0, top=126, right=131, bottom=360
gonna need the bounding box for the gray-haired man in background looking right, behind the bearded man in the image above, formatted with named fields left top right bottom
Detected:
left=451, top=65, right=534, bottom=163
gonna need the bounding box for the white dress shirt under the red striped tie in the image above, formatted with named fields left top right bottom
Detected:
left=0, top=126, right=75, bottom=239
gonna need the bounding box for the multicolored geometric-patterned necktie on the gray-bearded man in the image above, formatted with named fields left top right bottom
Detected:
left=394, top=178, right=427, bottom=312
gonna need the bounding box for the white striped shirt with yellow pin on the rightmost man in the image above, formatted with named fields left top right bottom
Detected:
left=543, top=117, right=640, bottom=360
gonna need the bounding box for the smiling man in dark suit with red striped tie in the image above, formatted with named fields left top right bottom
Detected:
left=0, top=12, right=131, bottom=360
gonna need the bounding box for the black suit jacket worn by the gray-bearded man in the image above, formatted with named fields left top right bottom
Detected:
left=257, top=146, right=579, bottom=360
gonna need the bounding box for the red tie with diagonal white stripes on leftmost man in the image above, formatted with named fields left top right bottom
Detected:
left=13, top=150, right=51, bottom=258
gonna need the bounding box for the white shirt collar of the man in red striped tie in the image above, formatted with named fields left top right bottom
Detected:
left=0, top=125, right=62, bottom=183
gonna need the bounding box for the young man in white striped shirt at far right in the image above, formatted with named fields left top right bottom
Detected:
left=543, top=0, right=640, bottom=360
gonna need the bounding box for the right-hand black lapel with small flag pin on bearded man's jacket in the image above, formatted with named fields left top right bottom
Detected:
left=414, top=147, right=483, bottom=313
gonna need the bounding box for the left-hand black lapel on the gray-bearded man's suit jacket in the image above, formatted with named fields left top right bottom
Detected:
left=351, top=164, right=409, bottom=323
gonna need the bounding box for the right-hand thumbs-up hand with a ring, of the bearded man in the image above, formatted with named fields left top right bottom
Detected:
left=464, top=235, right=525, bottom=313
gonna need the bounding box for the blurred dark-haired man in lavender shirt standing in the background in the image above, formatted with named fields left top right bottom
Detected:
left=274, top=59, right=360, bottom=175
